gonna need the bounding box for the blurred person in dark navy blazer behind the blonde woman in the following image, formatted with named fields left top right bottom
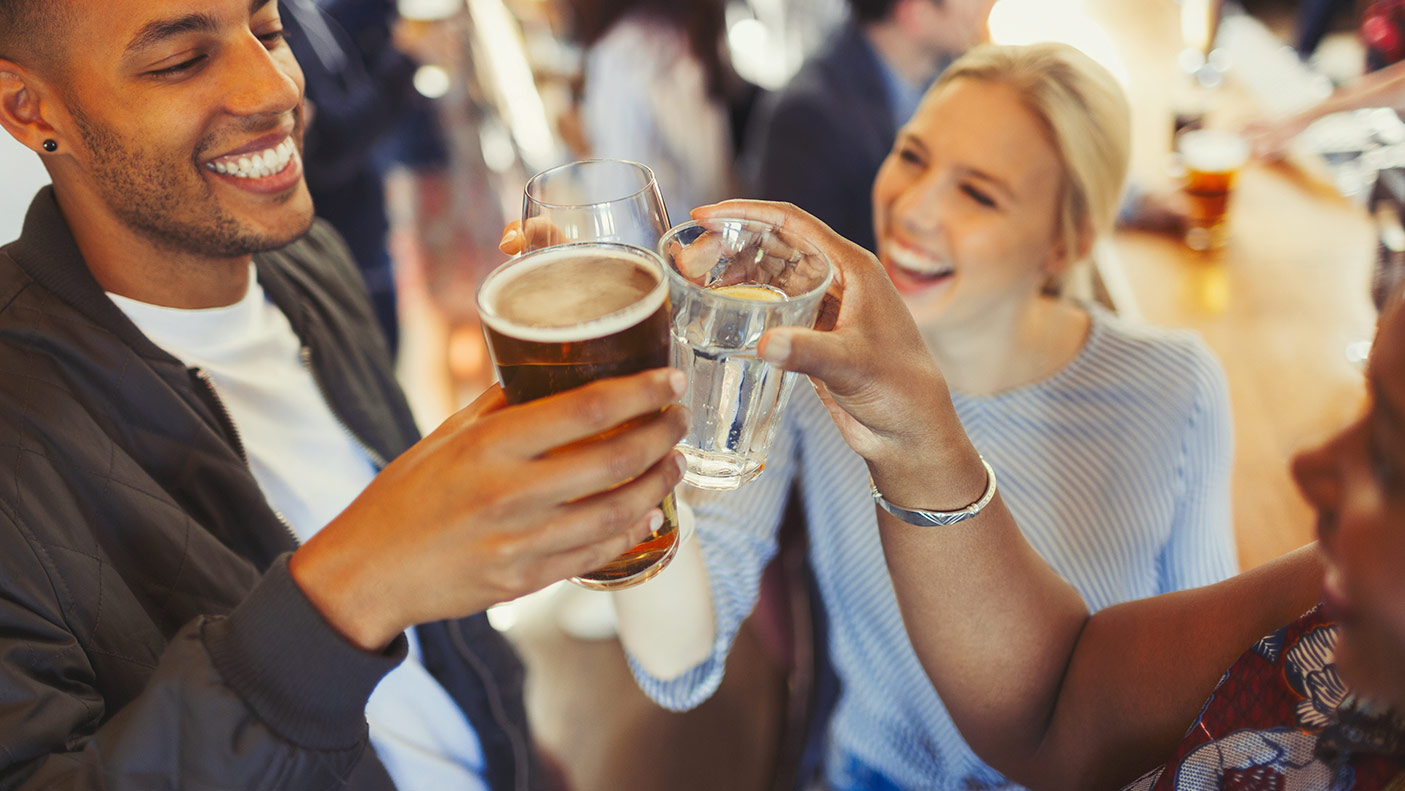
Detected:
left=742, top=0, right=995, bottom=250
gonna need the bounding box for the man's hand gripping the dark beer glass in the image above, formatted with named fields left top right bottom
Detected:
left=289, top=370, right=687, bottom=651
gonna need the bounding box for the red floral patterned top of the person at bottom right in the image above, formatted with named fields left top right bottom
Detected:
left=1124, top=607, right=1405, bottom=791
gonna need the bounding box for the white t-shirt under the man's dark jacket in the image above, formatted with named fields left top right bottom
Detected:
left=108, top=264, right=486, bottom=791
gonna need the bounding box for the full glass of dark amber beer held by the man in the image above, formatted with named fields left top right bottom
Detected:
left=478, top=243, right=679, bottom=590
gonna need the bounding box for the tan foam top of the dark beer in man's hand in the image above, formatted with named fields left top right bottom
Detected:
left=479, top=244, right=669, bottom=343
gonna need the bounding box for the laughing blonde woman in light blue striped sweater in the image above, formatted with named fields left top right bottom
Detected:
left=620, top=45, right=1236, bottom=791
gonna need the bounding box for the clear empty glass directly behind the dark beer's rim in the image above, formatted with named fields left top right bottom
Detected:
left=523, top=159, right=669, bottom=251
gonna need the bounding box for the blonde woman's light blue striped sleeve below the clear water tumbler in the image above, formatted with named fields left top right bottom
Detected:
left=618, top=404, right=802, bottom=711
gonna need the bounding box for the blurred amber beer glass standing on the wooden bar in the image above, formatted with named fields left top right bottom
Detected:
left=1176, top=129, right=1249, bottom=250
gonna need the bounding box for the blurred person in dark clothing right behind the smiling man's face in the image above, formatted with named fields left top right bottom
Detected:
left=280, top=0, right=447, bottom=358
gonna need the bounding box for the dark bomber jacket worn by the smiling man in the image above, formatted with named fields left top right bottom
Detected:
left=0, top=187, right=540, bottom=791
